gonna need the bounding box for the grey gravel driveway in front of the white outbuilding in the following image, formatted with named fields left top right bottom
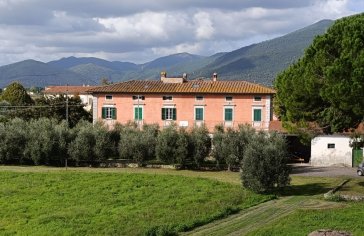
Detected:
left=291, top=163, right=364, bottom=179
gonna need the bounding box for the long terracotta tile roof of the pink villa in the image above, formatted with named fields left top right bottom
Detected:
left=88, top=80, right=275, bottom=94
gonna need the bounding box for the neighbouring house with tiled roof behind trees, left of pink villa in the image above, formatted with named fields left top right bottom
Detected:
left=43, top=85, right=97, bottom=111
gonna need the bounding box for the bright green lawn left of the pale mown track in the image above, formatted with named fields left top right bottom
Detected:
left=0, top=171, right=272, bottom=235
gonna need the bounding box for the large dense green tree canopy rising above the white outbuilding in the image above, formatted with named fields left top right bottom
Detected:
left=274, top=14, right=364, bottom=133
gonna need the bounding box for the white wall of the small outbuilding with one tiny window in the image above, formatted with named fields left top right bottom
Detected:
left=311, top=136, right=352, bottom=167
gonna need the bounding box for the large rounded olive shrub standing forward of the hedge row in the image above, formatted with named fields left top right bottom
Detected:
left=241, top=132, right=290, bottom=192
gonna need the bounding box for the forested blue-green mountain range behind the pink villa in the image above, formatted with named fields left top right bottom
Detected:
left=0, top=20, right=333, bottom=87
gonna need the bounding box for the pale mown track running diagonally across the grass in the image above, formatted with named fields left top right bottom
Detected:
left=181, top=196, right=339, bottom=236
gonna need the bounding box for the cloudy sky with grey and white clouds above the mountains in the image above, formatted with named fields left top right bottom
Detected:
left=0, top=0, right=364, bottom=65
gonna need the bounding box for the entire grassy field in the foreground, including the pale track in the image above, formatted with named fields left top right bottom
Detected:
left=0, top=166, right=364, bottom=236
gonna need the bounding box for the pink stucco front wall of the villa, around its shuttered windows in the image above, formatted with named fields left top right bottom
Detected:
left=94, top=94, right=271, bottom=132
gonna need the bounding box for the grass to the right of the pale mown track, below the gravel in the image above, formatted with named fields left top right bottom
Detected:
left=248, top=177, right=364, bottom=235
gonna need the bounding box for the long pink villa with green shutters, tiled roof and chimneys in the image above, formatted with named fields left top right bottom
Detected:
left=89, top=72, right=275, bottom=132
